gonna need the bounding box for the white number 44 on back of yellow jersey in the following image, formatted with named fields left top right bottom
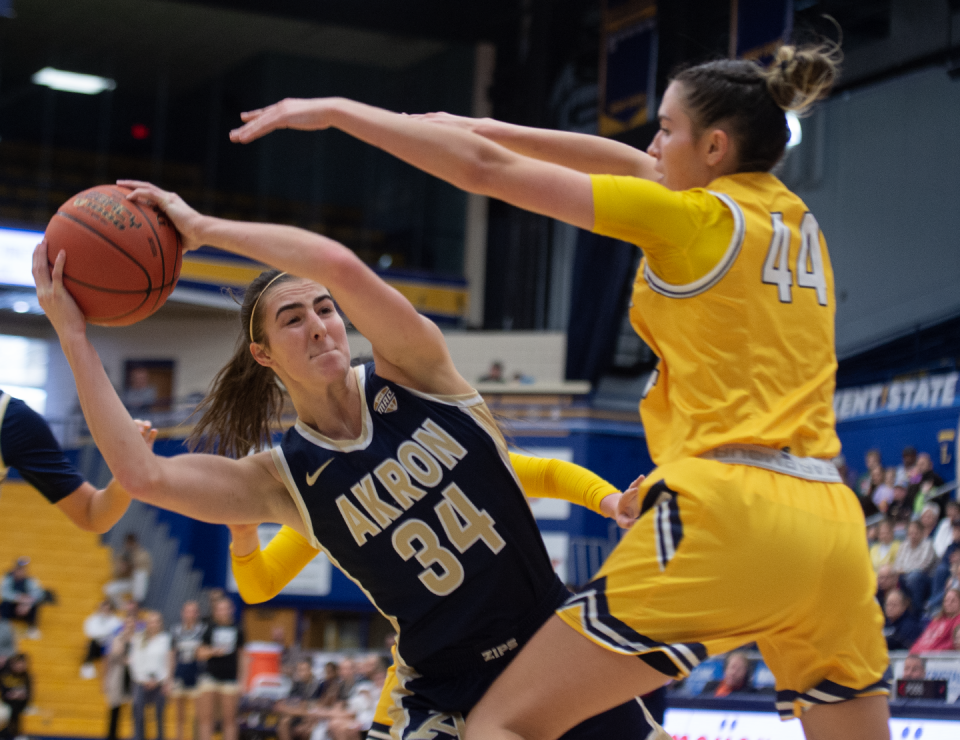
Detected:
left=763, top=213, right=827, bottom=306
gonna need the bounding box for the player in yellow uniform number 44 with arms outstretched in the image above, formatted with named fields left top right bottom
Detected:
left=231, top=39, right=889, bottom=740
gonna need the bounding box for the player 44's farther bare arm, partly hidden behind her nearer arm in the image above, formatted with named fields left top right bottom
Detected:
left=411, top=113, right=659, bottom=180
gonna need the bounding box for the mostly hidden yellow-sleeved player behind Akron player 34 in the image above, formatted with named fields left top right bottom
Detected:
left=230, top=450, right=653, bottom=740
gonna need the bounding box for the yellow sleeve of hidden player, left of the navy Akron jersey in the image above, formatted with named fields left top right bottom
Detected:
left=231, top=526, right=320, bottom=604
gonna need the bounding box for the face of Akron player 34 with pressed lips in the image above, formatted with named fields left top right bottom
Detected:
left=255, top=278, right=350, bottom=389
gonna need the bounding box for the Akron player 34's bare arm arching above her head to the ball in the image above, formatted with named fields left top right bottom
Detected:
left=118, top=181, right=468, bottom=394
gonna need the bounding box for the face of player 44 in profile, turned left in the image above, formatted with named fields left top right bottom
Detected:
left=647, top=82, right=713, bottom=190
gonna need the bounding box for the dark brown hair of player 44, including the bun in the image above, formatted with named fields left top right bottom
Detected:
left=670, top=42, right=842, bottom=172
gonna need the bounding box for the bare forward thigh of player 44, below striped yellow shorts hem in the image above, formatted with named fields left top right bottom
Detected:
left=466, top=617, right=668, bottom=740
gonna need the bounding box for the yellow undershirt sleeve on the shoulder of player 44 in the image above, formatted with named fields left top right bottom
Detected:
left=590, top=175, right=734, bottom=285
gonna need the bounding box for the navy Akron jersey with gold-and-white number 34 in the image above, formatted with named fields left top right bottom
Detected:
left=272, top=363, right=564, bottom=674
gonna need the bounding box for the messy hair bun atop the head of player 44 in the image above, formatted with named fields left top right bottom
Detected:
left=763, top=41, right=843, bottom=111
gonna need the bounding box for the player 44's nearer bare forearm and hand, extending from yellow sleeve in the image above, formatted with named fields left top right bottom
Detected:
left=230, top=98, right=594, bottom=229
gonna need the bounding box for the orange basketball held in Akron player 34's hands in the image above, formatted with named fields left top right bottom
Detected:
left=45, top=185, right=182, bottom=326
